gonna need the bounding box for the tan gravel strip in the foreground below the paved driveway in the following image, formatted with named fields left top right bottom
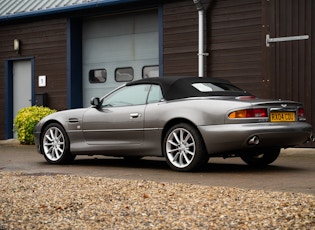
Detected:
left=0, top=172, right=315, bottom=229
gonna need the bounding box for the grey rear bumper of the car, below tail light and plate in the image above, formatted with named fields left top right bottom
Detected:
left=198, top=122, right=312, bottom=154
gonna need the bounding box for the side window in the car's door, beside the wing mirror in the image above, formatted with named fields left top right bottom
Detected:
left=102, top=84, right=150, bottom=107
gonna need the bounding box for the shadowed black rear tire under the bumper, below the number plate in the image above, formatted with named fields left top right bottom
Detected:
left=241, top=148, right=280, bottom=167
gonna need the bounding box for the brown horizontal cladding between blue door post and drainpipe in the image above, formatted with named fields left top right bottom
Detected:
left=163, top=0, right=198, bottom=76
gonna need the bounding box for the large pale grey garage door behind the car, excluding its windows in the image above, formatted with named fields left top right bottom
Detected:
left=83, top=10, right=159, bottom=107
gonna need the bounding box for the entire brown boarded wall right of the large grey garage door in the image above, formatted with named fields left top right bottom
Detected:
left=163, top=0, right=315, bottom=146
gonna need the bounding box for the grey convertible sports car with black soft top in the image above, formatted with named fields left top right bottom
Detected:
left=34, top=77, right=313, bottom=171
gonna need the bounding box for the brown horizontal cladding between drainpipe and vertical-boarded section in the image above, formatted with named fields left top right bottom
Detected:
left=207, top=0, right=263, bottom=97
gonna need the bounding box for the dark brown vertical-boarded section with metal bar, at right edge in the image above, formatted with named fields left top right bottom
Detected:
left=266, top=0, right=315, bottom=146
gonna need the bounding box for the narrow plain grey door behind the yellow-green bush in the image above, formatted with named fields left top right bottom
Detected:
left=13, top=60, right=32, bottom=129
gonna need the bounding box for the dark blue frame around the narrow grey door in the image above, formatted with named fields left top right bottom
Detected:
left=4, top=57, right=35, bottom=139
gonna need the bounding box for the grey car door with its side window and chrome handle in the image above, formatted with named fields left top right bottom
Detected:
left=82, top=85, right=150, bottom=150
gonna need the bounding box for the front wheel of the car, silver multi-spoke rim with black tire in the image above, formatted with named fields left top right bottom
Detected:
left=40, top=123, right=75, bottom=164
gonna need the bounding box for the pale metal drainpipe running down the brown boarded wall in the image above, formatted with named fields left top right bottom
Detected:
left=193, top=0, right=208, bottom=77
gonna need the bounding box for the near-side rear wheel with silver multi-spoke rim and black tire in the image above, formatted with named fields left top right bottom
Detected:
left=163, top=123, right=209, bottom=172
